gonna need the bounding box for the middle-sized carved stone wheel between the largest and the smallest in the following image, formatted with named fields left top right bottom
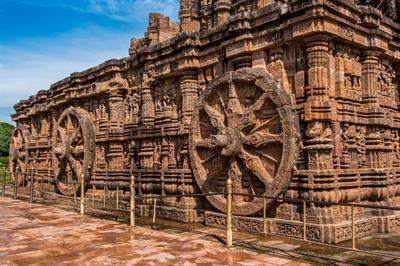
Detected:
left=53, top=107, right=96, bottom=196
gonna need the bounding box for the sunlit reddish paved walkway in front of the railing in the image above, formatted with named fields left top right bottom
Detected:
left=0, top=198, right=307, bottom=266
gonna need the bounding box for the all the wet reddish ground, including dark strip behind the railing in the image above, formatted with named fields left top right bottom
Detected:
left=0, top=198, right=400, bottom=265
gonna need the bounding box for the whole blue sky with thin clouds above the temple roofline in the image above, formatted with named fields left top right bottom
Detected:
left=0, top=0, right=179, bottom=122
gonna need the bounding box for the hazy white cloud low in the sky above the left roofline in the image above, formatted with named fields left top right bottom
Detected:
left=0, top=28, right=133, bottom=107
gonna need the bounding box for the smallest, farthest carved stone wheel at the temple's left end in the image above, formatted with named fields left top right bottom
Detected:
left=9, top=125, right=31, bottom=186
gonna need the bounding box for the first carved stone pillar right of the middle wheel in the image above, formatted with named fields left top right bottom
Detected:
left=108, top=89, right=125, bottom=129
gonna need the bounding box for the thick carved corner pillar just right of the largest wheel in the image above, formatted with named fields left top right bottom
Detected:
left=305, top=34, right=333, bottom=121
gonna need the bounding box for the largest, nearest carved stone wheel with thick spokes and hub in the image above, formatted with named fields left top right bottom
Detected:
left=190, top=68, right=300, bottom=215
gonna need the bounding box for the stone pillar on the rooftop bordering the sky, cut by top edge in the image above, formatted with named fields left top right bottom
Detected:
left=179, top=0, right=200, bottom=32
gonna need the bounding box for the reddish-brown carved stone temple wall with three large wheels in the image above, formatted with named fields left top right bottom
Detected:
left=10, top=0, right=400, bottom=242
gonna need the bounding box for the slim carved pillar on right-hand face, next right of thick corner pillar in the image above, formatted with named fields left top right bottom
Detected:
left=361, top=50, right=380, bottom=108
